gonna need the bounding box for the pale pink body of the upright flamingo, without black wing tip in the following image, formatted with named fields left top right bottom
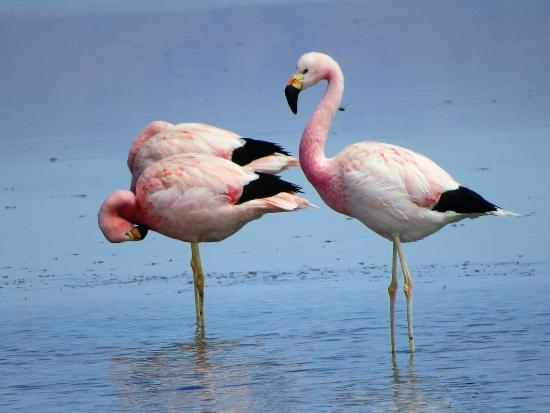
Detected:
left=324, top=141, right=496, bottom=242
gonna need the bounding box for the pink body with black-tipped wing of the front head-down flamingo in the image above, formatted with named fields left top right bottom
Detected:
left=136, top=154, right=309, bottom=242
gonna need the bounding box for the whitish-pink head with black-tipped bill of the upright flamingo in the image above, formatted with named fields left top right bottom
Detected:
left=285, top=52, right=338, bottom=114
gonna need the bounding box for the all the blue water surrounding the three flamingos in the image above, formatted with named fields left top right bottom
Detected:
left=0, top=0, right=550, bottom=412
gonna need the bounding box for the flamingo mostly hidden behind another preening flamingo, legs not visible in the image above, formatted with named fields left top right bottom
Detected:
left=127, top=121, right=299, bottom=191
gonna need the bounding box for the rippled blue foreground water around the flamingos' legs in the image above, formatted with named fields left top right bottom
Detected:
left=4, top=263, right=550, bottom=412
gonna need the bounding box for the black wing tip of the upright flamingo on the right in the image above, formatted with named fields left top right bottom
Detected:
left=432, top=186, right=499, bottom=214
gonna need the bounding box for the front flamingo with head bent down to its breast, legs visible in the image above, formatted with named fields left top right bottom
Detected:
left=98, top=154, right=310, bottom=327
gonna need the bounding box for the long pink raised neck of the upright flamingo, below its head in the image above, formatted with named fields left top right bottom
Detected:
left=300, top=64, right=344, bottom=186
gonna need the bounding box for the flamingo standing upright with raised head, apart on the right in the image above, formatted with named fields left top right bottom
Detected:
left=285, top=52, right=518, bottom=355
